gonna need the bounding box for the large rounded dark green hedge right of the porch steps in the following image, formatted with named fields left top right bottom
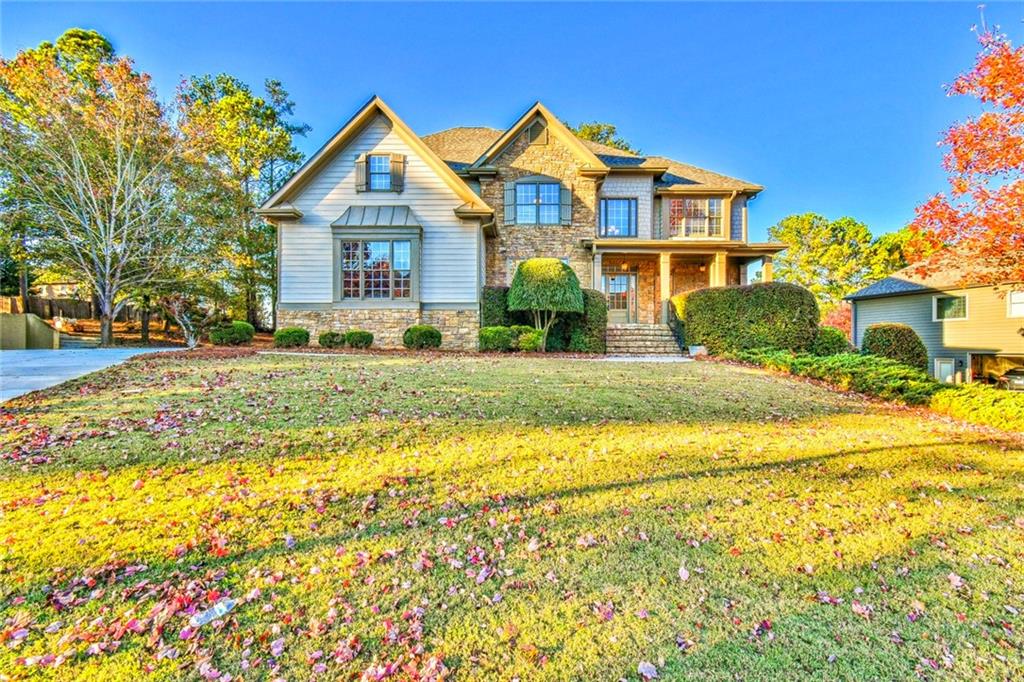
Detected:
left=673, top=282, right=820, bottom=354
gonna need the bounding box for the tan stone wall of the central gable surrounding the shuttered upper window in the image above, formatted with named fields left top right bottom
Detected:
left=480, top=122, right=597, bottom=287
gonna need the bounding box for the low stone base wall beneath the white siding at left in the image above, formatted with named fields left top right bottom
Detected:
left=278, top=308, right=480, bottom=350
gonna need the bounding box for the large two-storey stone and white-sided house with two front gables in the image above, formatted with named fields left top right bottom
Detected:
left=260, top=97, right=783, bottom=348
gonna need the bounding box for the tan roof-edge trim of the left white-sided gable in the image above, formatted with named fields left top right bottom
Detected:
left=259, top=95, right=492, bottom=217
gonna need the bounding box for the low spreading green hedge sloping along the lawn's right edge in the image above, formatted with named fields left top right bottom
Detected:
left=729, top=349, right=945, bottom=404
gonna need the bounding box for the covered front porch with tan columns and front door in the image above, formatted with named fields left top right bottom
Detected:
left=594, top=248, right=772, bottom=325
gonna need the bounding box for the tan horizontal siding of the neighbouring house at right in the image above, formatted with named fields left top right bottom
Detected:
left=853, top=287, right=1024, bottom=373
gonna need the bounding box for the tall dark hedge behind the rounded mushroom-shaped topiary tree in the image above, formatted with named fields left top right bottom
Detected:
left=480, top=287, right=608, bottom=353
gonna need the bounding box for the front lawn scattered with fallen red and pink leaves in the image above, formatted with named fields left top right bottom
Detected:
left=0, top=355, right=1024, bottom=680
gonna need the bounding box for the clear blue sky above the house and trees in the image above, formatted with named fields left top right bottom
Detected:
left=0, top=0, right=1024, bottom=239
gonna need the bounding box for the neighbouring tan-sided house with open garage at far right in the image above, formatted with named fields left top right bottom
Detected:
left=847, top=253, right=1024, bottom=383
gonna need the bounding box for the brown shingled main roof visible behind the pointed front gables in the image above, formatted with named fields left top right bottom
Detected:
left=423, top=114, right=764, bottom=195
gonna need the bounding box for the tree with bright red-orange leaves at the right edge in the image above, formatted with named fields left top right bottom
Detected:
left=912, top=31, right=1024, bottom=284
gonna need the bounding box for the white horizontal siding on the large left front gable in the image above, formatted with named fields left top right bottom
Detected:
left=280, top=116, right=481, bottom=306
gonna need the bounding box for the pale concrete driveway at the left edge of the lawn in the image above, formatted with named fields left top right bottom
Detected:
left=0, top=348, right=171, bottom=402
